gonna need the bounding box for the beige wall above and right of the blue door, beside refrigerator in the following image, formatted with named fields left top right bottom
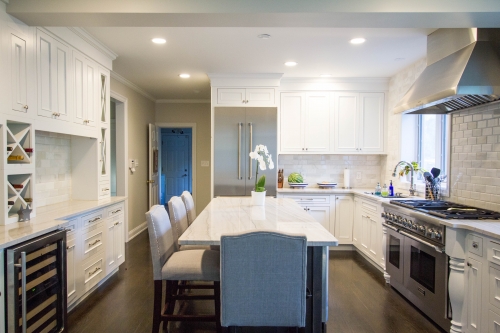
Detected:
left=156, top=103, right=211, bottom=212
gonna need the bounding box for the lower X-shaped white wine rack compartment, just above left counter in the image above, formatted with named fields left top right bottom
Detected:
left=6, top=174, right=33, bottom=222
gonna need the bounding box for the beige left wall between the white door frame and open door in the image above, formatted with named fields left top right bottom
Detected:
left=111, top=78, right=155, bottom=231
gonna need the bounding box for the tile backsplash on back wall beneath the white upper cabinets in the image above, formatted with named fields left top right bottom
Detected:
left=278, top=155, right=382, bottom=188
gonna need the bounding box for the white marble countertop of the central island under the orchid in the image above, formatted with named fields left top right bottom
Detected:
left=179, top=197, right=338, bottom=246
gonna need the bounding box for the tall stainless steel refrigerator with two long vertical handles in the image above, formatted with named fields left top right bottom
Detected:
left=214, top=107, right=278, bottom=196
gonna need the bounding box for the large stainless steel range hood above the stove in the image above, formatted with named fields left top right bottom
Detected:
left=394, top=28, right=500, bottom=114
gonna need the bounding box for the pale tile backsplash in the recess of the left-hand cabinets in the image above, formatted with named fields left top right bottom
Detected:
left=35, top=131, right=71, bottom=207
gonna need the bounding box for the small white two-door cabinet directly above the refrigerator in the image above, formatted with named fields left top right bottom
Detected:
left=217, top=88, right=275, bottom=106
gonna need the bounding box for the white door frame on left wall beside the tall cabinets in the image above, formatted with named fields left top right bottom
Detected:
left=109, top=90, right=131, bottom=243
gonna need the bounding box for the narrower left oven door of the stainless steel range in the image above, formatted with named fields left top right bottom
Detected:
left=384, top=223, right=405, bottom=287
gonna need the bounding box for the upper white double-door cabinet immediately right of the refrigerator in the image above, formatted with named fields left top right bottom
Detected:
left=280, top=92, right=332, bottom=153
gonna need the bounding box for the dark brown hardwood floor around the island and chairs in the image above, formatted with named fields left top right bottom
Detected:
left=68, top=232, right=443, bottom=333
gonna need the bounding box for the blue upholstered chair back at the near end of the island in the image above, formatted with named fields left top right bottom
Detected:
left=221, top=231, right=307, bottom=327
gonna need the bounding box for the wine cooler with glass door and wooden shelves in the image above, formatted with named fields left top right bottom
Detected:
left=5, top=231, right=67, bottom=333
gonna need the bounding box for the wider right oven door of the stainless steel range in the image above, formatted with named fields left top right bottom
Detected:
left=404, top=232, right=448, bottom=321
